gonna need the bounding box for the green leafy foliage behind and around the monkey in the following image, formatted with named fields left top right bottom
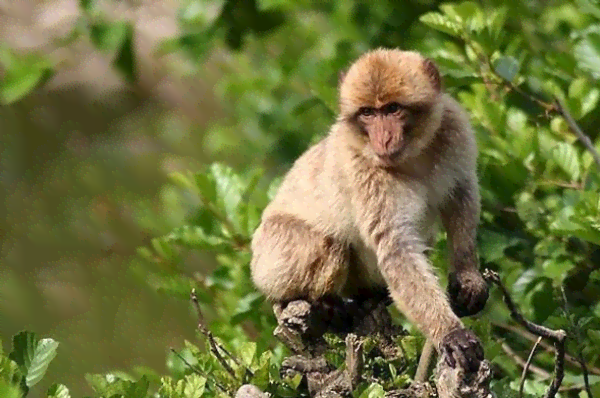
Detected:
left=0, top=0, right=600, bottom=397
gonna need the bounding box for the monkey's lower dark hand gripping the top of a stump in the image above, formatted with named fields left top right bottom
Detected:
left=439, top=329, right=483, bottom=373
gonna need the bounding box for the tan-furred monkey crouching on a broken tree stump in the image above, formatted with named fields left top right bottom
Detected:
left=250, top=48, right=488, bottom=371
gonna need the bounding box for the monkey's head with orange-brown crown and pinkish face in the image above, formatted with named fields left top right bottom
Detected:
left=339, top=49, right=443, bottom=166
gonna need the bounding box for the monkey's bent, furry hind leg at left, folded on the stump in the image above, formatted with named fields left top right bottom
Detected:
left=251, top=214, right=349, bottom=336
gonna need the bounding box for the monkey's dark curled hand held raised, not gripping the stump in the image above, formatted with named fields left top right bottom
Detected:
left=448, top=271, right=489, bottom=318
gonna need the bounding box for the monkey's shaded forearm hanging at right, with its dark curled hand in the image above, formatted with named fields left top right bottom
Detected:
left=440, top=176, right=489, bottom=317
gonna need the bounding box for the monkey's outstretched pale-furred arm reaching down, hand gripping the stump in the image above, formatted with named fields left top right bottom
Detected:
left=355, top=182, right=483, bottom=370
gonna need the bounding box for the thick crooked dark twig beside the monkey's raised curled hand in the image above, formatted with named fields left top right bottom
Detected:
left=483, top=269, right=567, bottom=398
